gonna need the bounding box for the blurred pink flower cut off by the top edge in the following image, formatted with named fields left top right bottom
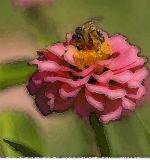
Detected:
left=14, top=0, right=54, bottom=8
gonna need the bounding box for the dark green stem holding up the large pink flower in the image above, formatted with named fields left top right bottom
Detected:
left=90, top=114, right=110, bottom=157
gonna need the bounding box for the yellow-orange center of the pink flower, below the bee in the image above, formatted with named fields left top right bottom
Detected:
left=74, top=41, right=112, bottom=69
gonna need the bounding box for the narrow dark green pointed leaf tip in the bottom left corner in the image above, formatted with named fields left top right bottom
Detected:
left=3, top=139, right=42, bottom=157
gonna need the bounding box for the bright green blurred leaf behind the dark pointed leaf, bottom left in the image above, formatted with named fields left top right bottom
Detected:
left=0, top=111, right=46, bottom=157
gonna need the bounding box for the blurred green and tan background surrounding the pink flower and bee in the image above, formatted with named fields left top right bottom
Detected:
left=0, top=0, right=150, bottom=157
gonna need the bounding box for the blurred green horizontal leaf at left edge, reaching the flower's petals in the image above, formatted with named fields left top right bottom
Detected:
left=0, top=60, right=36, bottom=89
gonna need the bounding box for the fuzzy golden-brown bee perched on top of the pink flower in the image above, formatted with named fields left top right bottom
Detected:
left=72, top=17, right=104, bottom=50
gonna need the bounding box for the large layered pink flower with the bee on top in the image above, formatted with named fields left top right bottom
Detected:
left=27, top=29, right=148, bottom=123
